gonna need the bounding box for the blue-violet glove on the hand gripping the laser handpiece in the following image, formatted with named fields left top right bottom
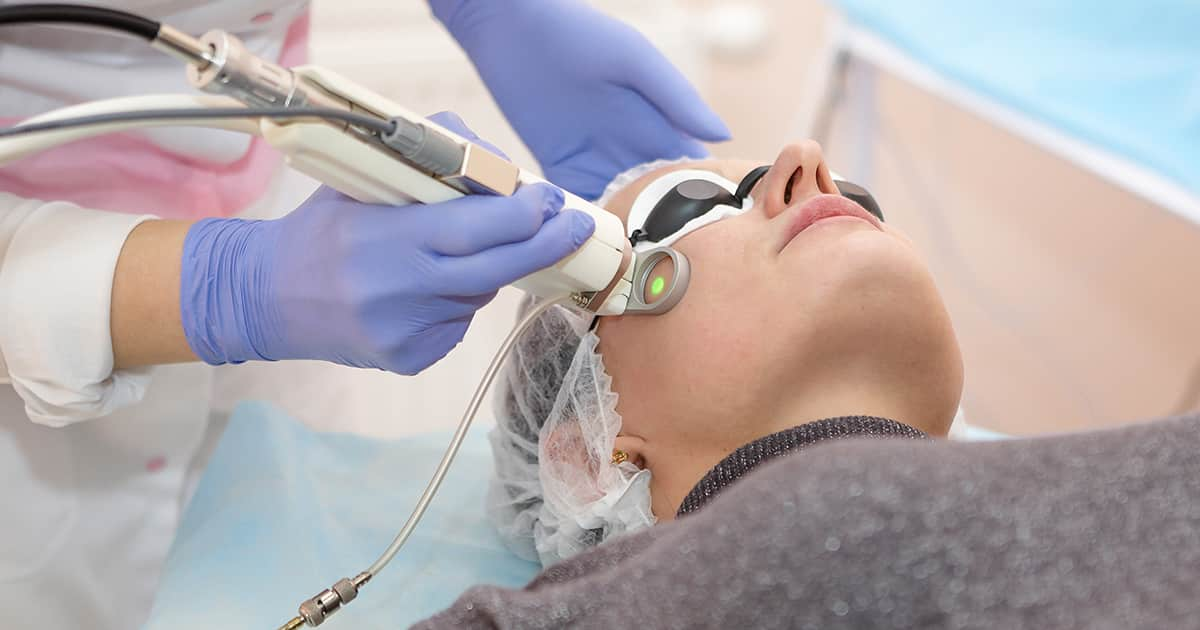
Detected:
left=180, top=111, right=595, bottom=374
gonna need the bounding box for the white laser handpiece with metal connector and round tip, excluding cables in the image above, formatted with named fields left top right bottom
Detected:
left=151, top=25, right=672, bottom=316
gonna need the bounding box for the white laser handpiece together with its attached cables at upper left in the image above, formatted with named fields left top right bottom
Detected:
left=0, top=9, right=688, bottom=314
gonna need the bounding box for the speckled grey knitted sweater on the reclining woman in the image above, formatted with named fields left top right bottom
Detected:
left=416, top=416, right=1200, bottom=630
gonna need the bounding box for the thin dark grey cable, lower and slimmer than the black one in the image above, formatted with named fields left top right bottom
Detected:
left=0, top=107, right=395, bottom=138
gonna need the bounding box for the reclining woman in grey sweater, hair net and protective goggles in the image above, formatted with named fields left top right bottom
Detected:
left=419, top=142, right=1200, bottom=629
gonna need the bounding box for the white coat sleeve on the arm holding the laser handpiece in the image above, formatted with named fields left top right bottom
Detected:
left=0, top=192, right=152, bottom=426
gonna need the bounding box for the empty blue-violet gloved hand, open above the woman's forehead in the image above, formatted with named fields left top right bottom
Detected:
left=430, top=0, right=730, bottom=199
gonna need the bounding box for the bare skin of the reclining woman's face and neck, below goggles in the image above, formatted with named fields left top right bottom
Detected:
left=599, top=142, right=962, bottom=492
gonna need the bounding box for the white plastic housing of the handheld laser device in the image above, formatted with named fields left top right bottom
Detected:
left=262, top=66, right=634, bottom=314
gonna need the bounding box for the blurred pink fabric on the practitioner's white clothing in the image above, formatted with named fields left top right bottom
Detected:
left=0, top=13, right=310, bottom=218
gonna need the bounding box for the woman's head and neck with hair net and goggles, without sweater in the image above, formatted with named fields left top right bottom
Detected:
left=490, top=142, right=962, bottom=565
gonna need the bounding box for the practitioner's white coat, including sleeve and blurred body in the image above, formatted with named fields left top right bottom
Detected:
left=0, top=0, right=307, bottom=630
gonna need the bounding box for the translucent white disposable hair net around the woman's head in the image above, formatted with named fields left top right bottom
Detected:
left=487, top=299, right=654, bottom=565
